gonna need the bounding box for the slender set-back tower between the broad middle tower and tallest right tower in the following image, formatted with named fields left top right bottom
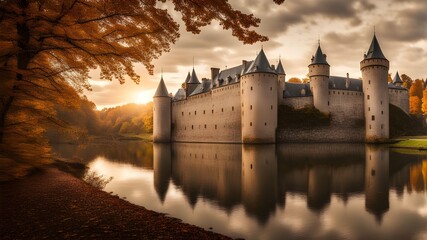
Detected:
left=308, top=43, right=330, bottom=113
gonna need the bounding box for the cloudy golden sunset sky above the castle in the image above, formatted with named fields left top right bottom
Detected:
left=85, top=0, right=427, bottom=109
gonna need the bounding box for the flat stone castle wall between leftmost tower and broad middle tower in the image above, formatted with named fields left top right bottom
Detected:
left=172, top=83, right=242, bottom=142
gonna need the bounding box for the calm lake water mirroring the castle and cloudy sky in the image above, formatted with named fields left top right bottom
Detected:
left=51, top=142, right=427, bottom=239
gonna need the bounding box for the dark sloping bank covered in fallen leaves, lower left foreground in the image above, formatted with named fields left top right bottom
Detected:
left=0, top=168, right=229, bottom=239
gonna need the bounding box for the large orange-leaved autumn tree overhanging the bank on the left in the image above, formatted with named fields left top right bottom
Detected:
left=0, top=0, right=283, bottom=172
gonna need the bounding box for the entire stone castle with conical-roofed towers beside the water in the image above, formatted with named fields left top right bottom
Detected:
left=153, top=34, right=409, bottom=143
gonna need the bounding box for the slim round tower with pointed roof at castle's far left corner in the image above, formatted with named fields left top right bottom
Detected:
left=153, top=76, right=172, bottom=142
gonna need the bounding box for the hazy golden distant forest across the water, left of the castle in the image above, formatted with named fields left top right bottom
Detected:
left=47, top=97, right=153, bottom=143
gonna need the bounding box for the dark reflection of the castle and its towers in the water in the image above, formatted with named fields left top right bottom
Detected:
left=153, top=143, right=427, bottom=224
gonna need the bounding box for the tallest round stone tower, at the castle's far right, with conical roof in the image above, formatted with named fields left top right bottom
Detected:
left=360, top=34, right=389, bottom=142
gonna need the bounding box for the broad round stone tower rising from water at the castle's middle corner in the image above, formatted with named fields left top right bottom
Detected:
left=240, top=49, right=278, bottom=143
